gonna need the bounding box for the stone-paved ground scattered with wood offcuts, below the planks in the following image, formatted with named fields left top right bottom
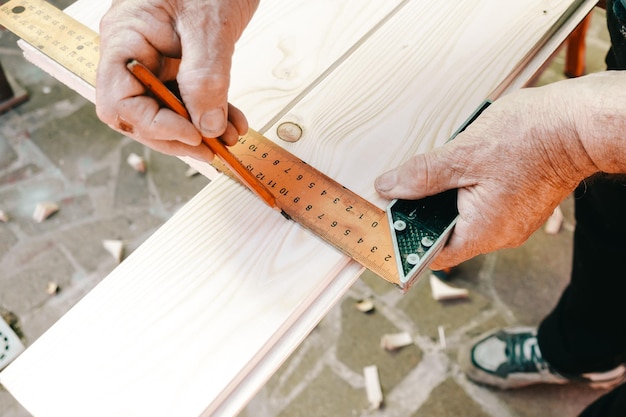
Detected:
left=0, top=4, right=608, bottom=417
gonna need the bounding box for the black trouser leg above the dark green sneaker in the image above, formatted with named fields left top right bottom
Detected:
left=539, top=176, right=626, bottom=374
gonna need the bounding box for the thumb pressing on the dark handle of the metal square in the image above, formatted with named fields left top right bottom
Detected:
left=374, top=146, right=459, bottom=200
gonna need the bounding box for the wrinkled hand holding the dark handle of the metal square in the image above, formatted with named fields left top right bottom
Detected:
left=376, top=87, right=593, bottom=270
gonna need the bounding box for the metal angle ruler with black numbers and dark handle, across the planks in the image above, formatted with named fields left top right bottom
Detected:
left=0, top=0, right=486, bottom=291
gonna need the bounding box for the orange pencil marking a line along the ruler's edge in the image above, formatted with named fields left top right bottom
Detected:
left=127, top=60, right=282, bottom=212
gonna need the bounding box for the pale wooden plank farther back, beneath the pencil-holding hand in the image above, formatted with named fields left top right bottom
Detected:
left=20, top=0, right=403, bottom=179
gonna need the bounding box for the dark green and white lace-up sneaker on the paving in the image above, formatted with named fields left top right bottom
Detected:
left=459, top=327, right=626, bottom=389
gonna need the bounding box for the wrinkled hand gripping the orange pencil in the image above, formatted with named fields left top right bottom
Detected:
left=96, top=0, right=258, bottom=161
